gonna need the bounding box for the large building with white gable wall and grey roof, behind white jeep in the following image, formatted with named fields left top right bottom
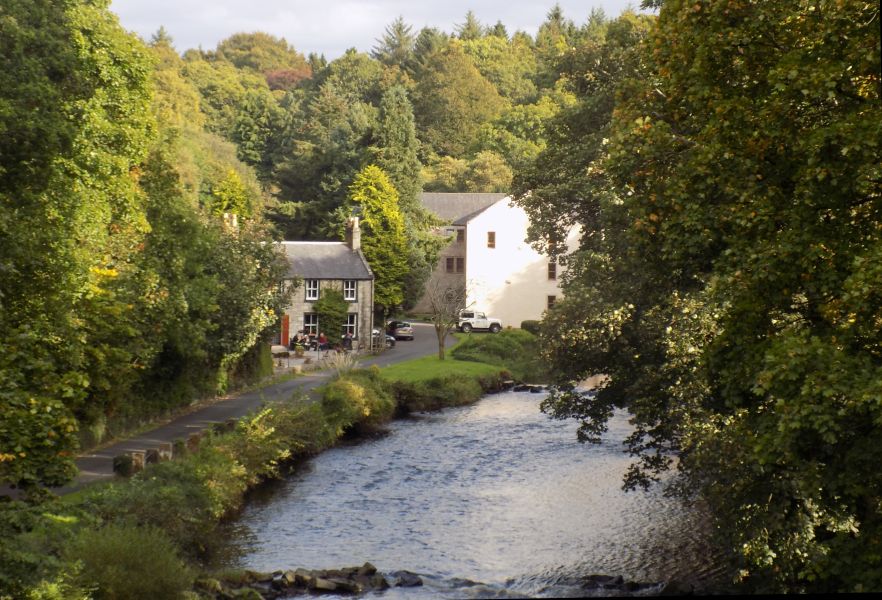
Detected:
left=414, top=193, right=578, bottom=327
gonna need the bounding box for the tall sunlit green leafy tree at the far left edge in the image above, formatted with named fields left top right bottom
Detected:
left=0, top=0, right=152, bottom=487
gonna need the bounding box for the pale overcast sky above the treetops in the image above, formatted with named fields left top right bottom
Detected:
left=111, top=0, right=640, bottom=60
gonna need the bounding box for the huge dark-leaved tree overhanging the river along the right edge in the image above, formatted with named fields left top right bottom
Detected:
left=518, top=0, right=882, bottom=592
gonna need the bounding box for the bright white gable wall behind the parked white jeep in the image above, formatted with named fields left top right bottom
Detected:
left=466, top=198, right=578, bottom=327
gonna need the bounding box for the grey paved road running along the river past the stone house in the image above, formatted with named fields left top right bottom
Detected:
left=56, top=323, right=454, bottom=494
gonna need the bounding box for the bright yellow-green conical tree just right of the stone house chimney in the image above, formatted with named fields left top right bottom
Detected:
left=348, top=165, right=407, bottom=320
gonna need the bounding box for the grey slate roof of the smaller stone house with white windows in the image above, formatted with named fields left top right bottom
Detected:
left=281, top=242, right=374, bottom=279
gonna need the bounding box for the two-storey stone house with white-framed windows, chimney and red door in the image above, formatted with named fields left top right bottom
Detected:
left=274, top=217, right=374, bottom=347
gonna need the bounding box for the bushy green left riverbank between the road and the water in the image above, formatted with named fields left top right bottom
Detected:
left=0, top=330, right=528, bottom=600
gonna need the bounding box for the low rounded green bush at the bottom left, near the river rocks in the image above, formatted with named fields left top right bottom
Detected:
left=63, top=524, right=193, bottom=600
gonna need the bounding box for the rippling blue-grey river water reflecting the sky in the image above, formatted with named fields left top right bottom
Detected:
left=230, top=392, right=722, bottom=598
